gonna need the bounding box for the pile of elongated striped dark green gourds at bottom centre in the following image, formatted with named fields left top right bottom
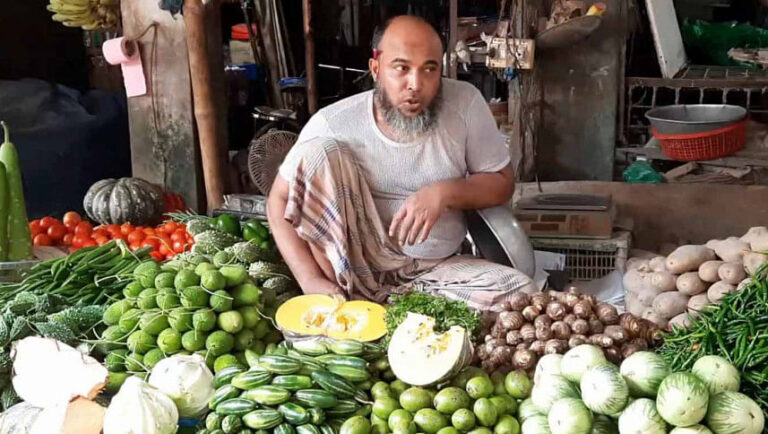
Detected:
left=203, top=340, right=393, bottom=434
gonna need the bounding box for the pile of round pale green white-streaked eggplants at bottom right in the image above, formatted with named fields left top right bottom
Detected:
left=518, top=345, right=765, bottom=434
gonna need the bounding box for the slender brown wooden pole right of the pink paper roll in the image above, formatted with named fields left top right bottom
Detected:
left=184, top=0, right=226, bottom=213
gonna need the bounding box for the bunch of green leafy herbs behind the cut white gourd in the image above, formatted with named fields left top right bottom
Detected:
left=386, top=292, right=480, bottom=338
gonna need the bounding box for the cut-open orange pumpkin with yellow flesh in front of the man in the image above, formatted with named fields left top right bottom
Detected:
left=275, top=294, right=387, bottom=342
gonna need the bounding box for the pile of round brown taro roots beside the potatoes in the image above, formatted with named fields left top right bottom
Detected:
left=477, top=288, right=661, bottom=372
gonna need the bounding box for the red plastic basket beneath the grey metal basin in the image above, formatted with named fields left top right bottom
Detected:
left=651, top=119, right=747, bottom=161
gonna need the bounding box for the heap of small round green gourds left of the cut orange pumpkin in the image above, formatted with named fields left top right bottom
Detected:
left=94, top=253, right=282, bottom=384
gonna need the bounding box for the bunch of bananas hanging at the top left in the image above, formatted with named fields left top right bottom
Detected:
left=46, top=0, right=120, bottom=30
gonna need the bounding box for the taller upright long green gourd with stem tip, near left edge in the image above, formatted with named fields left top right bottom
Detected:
left=0, top=122, right=32, bottom=261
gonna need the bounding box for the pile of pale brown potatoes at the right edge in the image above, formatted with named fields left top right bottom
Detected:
left=624, top=226, right=768, bottom=328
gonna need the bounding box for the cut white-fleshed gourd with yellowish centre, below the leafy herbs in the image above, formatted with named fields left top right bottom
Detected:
left=387, top=312, right=472, bottom=386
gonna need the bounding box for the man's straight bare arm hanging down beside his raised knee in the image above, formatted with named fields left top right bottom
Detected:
left=267, top=175, right=343, bottom=295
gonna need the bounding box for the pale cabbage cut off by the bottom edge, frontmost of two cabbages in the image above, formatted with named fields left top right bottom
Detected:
left=104, top=377, right=179, bottom=434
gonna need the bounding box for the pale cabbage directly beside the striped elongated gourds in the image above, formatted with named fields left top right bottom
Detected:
left=149, top=354, right=215, bottom=417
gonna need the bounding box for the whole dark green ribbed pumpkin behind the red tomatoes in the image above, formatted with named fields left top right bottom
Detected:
left=83, top=178, right=165, bottom=225
